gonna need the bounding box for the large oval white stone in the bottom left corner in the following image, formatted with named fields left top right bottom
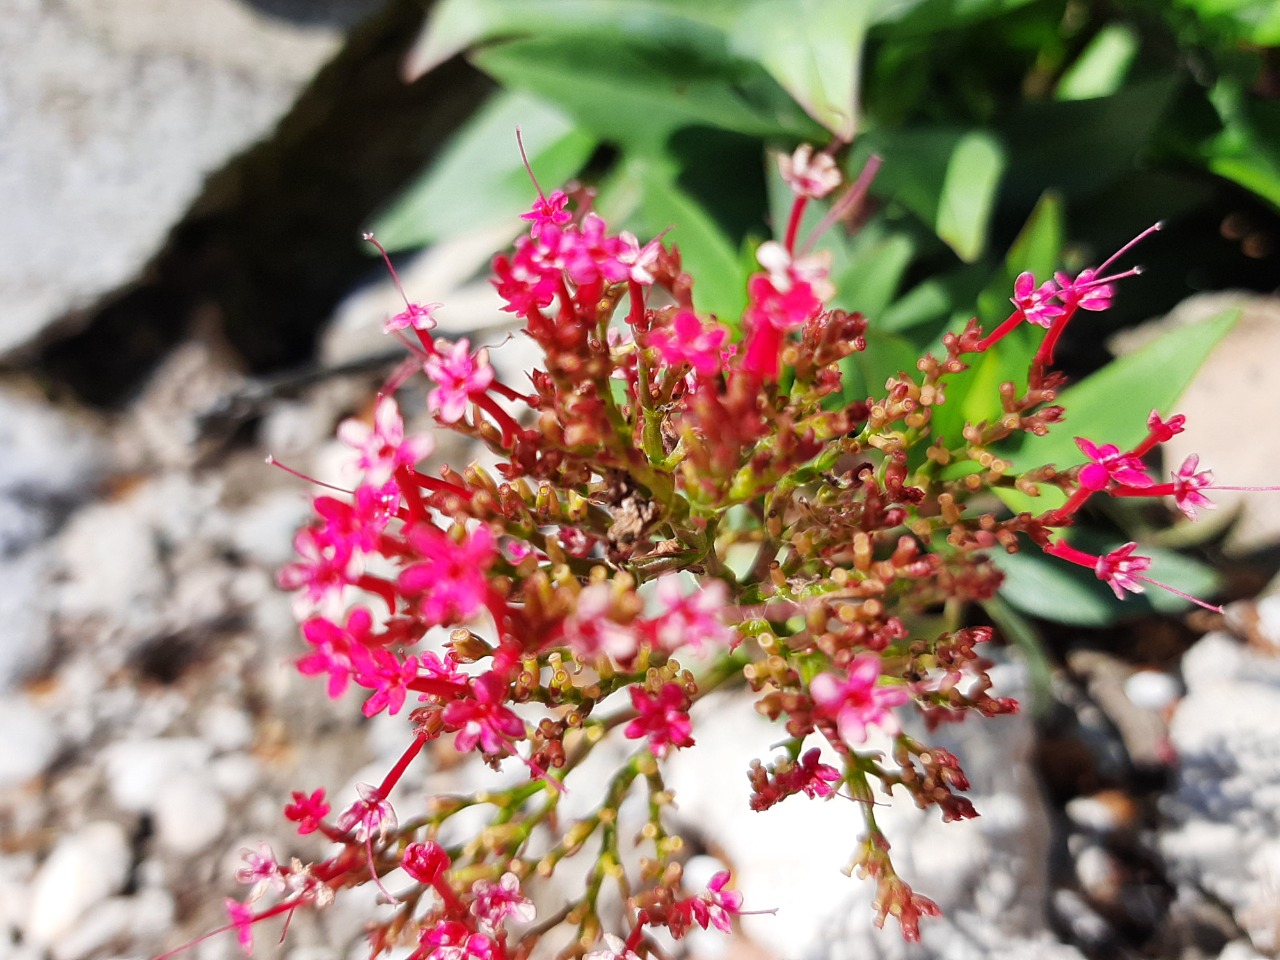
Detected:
left=23, top=820, right=131, bottom=947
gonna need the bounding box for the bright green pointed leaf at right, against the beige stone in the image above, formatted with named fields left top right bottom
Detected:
left=1001, top=308, right=1240, bottom=471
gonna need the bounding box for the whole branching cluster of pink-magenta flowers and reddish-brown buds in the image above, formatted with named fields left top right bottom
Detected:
left=189, top=147, right=1269, bottom=960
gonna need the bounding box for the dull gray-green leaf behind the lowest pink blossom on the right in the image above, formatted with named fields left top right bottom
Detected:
left=991, top=532, right=1221, bottom=627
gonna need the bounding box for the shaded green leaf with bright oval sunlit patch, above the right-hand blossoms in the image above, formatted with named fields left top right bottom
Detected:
left=855, top=128, right=1005, bottom=262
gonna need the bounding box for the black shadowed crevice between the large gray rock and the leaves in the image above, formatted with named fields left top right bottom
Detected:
left=38, top=0, right=493, bottom=407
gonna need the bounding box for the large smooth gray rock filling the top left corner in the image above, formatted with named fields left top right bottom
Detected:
left=0, top=0, right=380, bottom=356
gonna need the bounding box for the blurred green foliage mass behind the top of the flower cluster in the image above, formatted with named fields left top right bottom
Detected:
left=375, top=0, right=1280, bottom=620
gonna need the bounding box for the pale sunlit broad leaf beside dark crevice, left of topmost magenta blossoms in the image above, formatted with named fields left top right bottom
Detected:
left=372, top=92, right=596, bottom=250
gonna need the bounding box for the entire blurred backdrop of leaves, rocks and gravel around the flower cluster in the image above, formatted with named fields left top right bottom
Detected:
left=0, top=0, right=1280, bottom=960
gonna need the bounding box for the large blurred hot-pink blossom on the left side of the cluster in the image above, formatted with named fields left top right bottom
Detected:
left=397, top=524, right=498, bottom=625
